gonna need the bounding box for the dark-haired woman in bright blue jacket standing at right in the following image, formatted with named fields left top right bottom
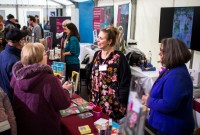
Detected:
left=143, top=38, right=194, bottom=135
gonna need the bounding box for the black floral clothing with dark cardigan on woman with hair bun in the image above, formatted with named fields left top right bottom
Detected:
left=90, top=50, right=131, bottom=120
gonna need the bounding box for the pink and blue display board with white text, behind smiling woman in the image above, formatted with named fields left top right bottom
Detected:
left=93, top=6, right=114, bottom=31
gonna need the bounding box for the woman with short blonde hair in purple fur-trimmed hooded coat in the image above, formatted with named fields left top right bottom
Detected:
left=11, top=43, right=72, bottom=135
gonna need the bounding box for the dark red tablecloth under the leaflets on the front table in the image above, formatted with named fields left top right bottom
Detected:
left=61, top=94, right=109, bottom=135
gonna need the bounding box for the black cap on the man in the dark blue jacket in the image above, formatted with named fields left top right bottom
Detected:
left=6, top=28, right=28, bottom=42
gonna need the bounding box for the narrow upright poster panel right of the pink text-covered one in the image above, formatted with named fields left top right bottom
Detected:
left=117, top=4, right=129, bottom=41
